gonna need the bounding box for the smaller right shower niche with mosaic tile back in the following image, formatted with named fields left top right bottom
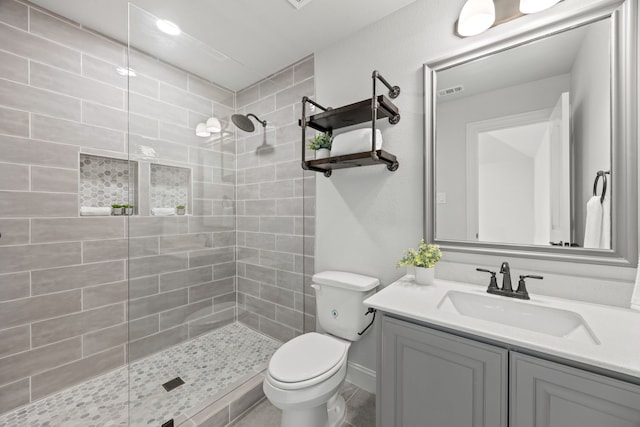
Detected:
left=149, top=164, right=191, bottom=210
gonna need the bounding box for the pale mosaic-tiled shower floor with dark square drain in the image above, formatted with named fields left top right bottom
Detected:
left=0, top=323, right=281, bottom=427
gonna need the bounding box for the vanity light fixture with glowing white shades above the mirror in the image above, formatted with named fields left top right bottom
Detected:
left=455, top=0, right=562, bottom=37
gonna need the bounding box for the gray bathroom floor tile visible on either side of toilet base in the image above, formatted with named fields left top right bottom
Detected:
left=232, top=382, right=376, bottom=427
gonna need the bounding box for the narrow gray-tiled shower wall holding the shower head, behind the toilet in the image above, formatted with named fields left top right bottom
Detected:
left=236, top=57, right=315, bottom=341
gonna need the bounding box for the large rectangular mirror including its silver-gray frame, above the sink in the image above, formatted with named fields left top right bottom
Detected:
left=425, top=0, right=638, bottom=266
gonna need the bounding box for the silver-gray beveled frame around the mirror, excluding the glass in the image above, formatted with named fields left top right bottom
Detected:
left=424, top=0, right=638, bottom=268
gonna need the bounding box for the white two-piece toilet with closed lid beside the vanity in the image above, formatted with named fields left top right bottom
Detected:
left=263, top=271, right=380, bottom=427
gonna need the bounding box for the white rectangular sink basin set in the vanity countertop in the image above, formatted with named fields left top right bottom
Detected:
left=438, top=291, right=600, bottom=344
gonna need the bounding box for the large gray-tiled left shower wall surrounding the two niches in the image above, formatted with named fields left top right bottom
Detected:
left=0, top=0, right=236, bottom=412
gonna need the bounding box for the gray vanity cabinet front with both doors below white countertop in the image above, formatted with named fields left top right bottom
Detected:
left=377, top=315, right=640, bottom=427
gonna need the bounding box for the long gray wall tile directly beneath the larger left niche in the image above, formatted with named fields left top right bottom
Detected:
left=31, top=217, right=125, bottom=243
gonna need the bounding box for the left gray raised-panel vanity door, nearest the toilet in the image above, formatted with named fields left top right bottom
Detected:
left=378, top=316, right=508, bottom=427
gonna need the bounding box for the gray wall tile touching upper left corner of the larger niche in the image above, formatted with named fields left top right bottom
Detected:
left=0, top=135, right=78, bottom=168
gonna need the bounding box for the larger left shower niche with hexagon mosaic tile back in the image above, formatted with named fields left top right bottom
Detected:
left=79, top=154, right=138, bottom=207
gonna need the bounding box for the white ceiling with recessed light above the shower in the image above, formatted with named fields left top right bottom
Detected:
left=32, top=0, right=415, bottom=90
